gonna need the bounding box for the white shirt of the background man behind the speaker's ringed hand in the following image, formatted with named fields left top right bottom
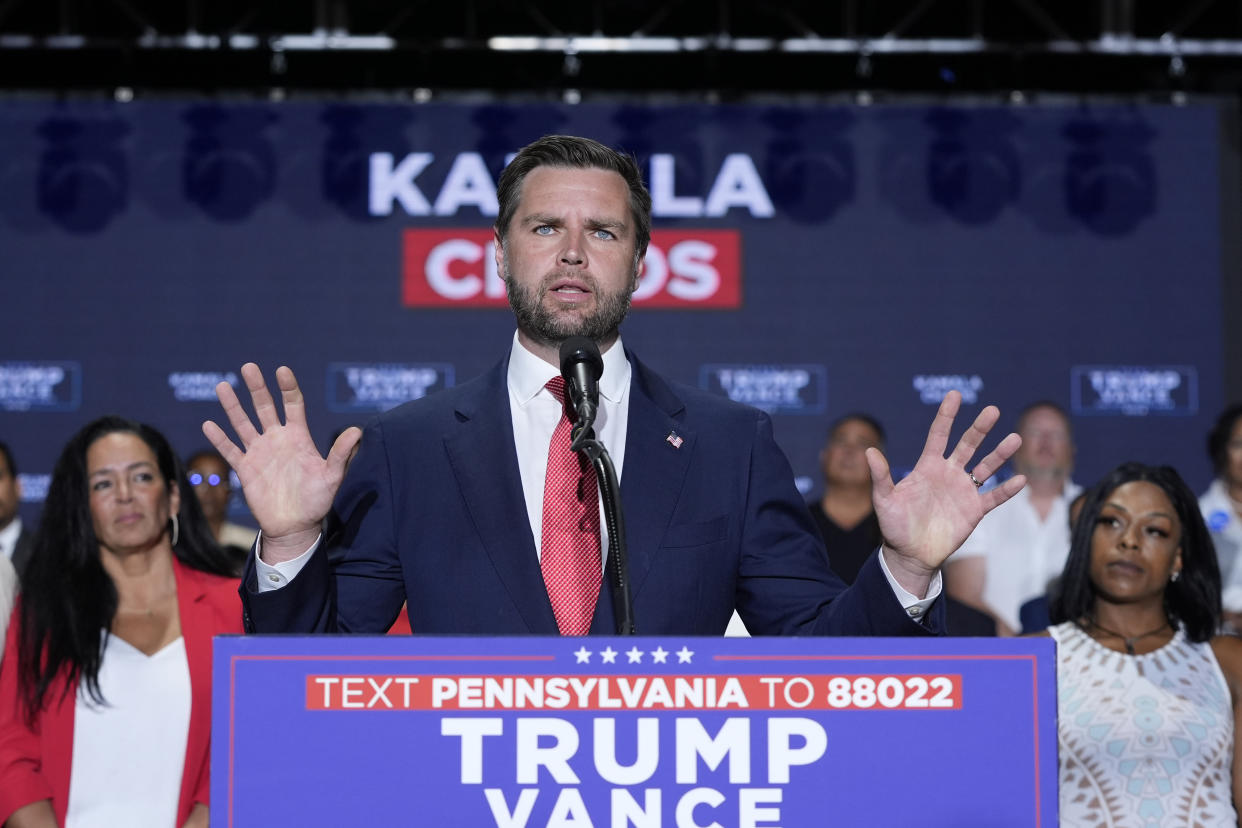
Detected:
left=953, top=482, right=1082, bottom=629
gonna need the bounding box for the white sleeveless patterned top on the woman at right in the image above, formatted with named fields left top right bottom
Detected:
left=1048, top=622, right=1237, bottom=828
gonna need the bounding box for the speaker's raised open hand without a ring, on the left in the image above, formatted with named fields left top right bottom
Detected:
left=202, top=362, right=363, bottom=564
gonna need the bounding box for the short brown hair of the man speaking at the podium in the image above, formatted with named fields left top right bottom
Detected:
left=496, top=135, right=651, bottom=259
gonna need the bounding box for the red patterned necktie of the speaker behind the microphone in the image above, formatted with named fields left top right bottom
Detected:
left=539, top=376, right=602, bottom=636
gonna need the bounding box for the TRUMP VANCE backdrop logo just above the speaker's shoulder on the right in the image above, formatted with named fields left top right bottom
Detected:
left=699, top=365, right=828, bottom=415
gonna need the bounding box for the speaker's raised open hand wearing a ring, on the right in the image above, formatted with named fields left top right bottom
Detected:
left=867, top=391, right=1026, bottom=597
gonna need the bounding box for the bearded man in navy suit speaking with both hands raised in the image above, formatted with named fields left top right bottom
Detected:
left=204, top=137, right=1022, bottom=636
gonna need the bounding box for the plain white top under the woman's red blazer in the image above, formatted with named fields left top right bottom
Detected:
left=65, top=636, right=190, bottom=828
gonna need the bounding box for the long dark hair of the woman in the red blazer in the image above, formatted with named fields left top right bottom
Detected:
left=17, top=416, right=231, bottom=720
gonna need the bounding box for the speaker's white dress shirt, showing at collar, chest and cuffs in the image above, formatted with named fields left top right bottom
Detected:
left=255, top=333, right=941, bottom=617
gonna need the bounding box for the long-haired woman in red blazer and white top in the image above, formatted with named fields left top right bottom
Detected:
left=0, top=417, right=242, bottom=828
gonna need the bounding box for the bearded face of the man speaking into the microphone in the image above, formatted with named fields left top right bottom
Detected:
left=496, top=166, right=641, bottom=346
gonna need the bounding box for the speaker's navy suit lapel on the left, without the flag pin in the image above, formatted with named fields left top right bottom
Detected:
left=445, top=359, right=556, bottom=634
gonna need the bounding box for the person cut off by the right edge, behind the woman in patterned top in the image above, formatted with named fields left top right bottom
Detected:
left=1199, top=405, right=1242, bottom=631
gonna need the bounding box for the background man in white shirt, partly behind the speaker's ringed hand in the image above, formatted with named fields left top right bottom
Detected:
left=944, top=401, right=1082, bottom=636
